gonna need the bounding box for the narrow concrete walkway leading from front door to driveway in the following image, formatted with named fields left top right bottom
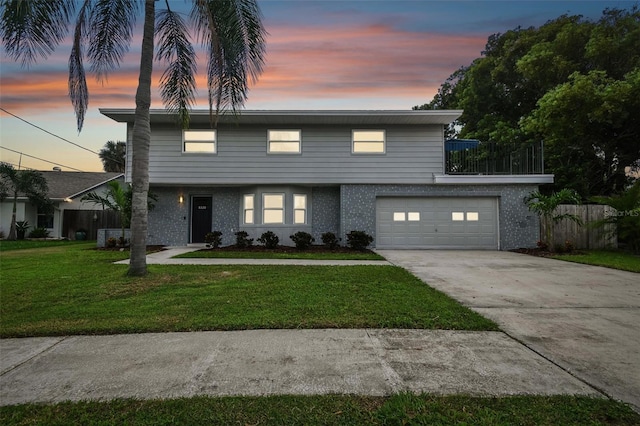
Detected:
left=115, top=246, right=391, bottom=266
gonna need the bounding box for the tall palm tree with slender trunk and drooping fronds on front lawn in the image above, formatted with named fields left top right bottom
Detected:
left=0, top=0, right=266, bottom=276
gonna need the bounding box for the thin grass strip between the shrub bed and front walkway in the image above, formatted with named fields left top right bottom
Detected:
left=174, top=249, right=384, bottom=260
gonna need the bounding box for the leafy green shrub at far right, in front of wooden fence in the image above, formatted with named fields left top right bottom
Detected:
left=592, top=180, right=640, bottom=253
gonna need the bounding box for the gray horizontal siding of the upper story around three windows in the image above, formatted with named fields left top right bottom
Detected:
left=141, top=121, right=443, bottom=185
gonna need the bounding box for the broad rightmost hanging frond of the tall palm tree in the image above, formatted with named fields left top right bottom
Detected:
left=192, top=0, right=266, bottom=125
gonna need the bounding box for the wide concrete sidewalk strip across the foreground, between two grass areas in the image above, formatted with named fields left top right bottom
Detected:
left=0, top=329, right=602, bottom=405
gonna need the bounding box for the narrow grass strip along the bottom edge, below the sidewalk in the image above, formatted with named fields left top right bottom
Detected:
left=0, top=393, right=640, bottom=426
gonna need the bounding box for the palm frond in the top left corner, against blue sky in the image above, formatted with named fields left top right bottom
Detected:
left=0, top=0, right=76, bottom=66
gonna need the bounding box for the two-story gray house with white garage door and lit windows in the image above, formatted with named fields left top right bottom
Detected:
left=100, top=108, right=553, bottom=250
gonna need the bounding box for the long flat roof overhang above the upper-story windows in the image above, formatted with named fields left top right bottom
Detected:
left=100, top=108, right=462, bottom=126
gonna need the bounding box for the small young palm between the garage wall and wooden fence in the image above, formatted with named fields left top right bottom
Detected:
left=525, top=188, right=582, bottom=250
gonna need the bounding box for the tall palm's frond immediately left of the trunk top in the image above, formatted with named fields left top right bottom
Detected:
left=87, top=0, right=140, bottom=81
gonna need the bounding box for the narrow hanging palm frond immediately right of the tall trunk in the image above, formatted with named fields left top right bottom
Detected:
left=156, top=10, right=197, bottom=128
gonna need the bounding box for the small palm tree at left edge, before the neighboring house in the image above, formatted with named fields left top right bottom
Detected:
left=0, top=163, right=53, bottom=240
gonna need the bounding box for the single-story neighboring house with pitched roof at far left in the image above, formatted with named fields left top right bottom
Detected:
left=0, top=171, right=124, bottom=239
